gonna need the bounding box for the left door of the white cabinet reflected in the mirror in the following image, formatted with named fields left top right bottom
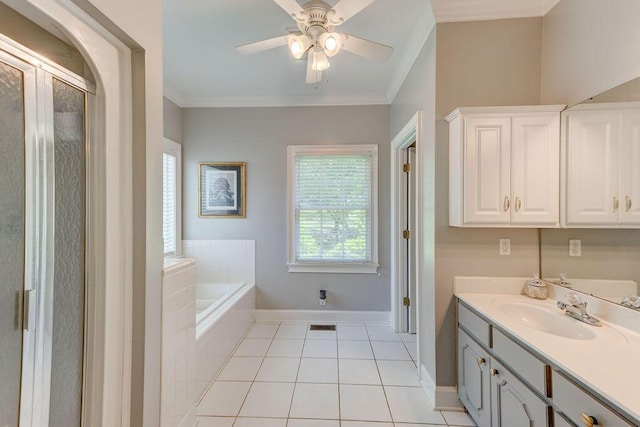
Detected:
left=565, top=111, right=619, bottom=225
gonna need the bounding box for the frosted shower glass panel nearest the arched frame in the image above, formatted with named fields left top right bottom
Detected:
left=49, top=79, right=85, bottom=427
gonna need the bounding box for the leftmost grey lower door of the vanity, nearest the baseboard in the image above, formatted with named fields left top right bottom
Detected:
left=458, top=329, right=491, bottom=427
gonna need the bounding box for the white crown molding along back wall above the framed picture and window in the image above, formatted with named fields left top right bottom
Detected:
left=174, top=93, right=389, bottom=108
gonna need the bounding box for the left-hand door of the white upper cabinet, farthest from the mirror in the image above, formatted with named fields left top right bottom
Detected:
left=464, top=117, right=512, bottom=225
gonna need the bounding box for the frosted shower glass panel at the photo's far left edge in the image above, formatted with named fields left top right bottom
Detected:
left=0, top=62, right=25, bottom=426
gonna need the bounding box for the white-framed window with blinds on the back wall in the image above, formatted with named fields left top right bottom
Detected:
left=287, top=145, right=378, bottom=273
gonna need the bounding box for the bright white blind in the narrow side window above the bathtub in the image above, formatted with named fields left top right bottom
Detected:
left=162, top=153, right=178, bottom=255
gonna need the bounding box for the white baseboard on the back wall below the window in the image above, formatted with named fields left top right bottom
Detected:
left=256, top=309, right=391, bottom=325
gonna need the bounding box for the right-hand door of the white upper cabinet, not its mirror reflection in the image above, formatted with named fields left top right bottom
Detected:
left=511, top=113, right=560, bottom=225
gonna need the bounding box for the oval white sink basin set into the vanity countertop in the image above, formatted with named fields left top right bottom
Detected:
left=500, top=302, right=596, bottom=340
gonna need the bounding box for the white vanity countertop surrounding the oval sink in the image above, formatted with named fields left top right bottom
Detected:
left=454, top=277, right=640, bottom=424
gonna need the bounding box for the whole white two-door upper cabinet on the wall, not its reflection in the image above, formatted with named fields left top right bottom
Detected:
left=447, top=105, right=564, bottom=227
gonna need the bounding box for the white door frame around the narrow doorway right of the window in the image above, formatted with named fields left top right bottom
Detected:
left=391, top=111, right=424, bottom=332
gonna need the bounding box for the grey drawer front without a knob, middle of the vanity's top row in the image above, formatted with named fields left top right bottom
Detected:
left=493, top=329, right=547, bottom=396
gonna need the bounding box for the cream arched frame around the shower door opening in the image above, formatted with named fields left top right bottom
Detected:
left=2, top=0, right=134, bottom=426
